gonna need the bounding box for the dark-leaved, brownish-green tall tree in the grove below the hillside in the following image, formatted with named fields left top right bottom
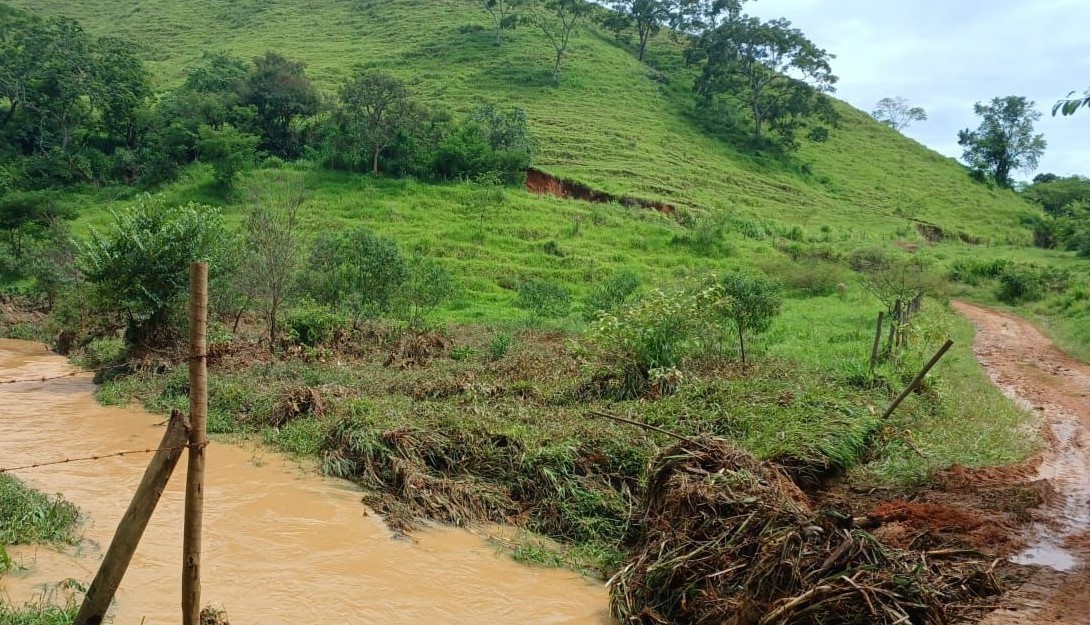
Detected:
left=241, top=52, right=318, bottom=157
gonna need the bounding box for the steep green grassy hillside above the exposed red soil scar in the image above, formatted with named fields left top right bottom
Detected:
left=14, top=0, right=1029, bottom=243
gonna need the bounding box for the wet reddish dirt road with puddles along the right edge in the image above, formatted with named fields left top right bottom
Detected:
left=954, top=302, right=1090, bottom=625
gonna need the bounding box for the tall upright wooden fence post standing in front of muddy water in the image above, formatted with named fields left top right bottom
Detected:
left=182, top=263, right=208, bottom=625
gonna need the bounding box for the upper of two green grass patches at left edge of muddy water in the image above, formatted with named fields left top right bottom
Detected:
left=0, top=473, right=80, bottom=545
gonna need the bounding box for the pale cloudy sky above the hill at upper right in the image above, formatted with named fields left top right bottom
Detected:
left=747, top=0, right=1090, bottom=178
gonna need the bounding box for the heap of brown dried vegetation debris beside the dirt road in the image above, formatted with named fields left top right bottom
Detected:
left=610, top=437, right=1001, bottom=625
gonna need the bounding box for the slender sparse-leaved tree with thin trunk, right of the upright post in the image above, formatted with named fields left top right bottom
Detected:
left=237, top=177, right=306, bottom=349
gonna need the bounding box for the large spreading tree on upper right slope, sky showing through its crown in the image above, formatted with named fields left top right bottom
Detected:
left=687, top=9, right=837, bottom=148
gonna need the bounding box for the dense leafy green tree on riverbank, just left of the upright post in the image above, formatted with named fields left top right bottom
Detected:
left=77, top=197, right=223, bottom=345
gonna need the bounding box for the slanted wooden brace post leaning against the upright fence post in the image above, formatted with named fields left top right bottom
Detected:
left=75, top=410, right=190, bottom=625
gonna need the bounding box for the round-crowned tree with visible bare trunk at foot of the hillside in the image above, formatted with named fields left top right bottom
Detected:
left=335, top=70, right=425, bottom=176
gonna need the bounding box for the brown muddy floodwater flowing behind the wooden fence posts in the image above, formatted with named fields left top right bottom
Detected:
left=0, top=340, right=609, bottom=625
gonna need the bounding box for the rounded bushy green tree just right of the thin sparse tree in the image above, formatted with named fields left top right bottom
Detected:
left=305, top=226, right=409, bottom=320
